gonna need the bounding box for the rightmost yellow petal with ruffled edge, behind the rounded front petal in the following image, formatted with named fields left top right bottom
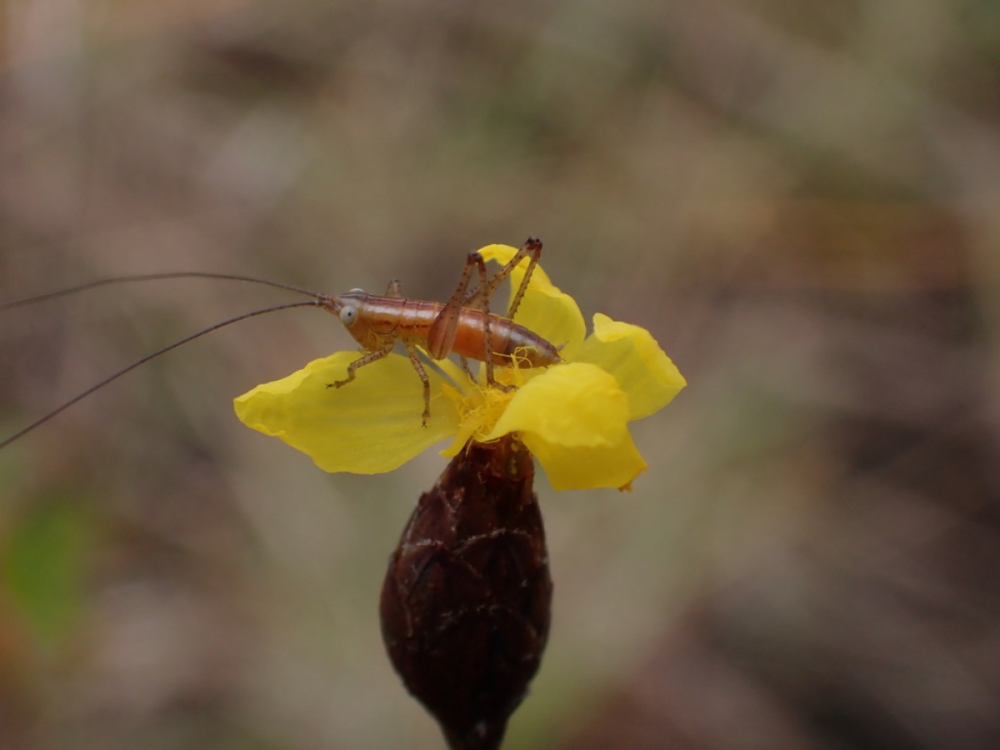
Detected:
left=576, top=313, right=687, bottom=419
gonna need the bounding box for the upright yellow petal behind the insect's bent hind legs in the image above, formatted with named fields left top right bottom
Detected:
left=479, top=245, right=587, bottom=359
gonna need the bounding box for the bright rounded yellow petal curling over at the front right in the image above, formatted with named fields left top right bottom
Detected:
left=483, top=363, right=628, bottom=447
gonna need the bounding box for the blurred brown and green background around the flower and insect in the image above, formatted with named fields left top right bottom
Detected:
left=0, top=0, right=1000, bottom=750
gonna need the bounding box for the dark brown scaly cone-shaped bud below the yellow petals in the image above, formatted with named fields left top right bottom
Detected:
left=381, top=436, right=552, bottom=750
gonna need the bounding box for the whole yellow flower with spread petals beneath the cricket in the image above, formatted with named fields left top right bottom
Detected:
left=235, top=245, right=686, bottom=490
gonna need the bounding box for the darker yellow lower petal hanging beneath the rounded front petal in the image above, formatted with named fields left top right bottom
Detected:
left=522, top=431, right=646, bottom=490
